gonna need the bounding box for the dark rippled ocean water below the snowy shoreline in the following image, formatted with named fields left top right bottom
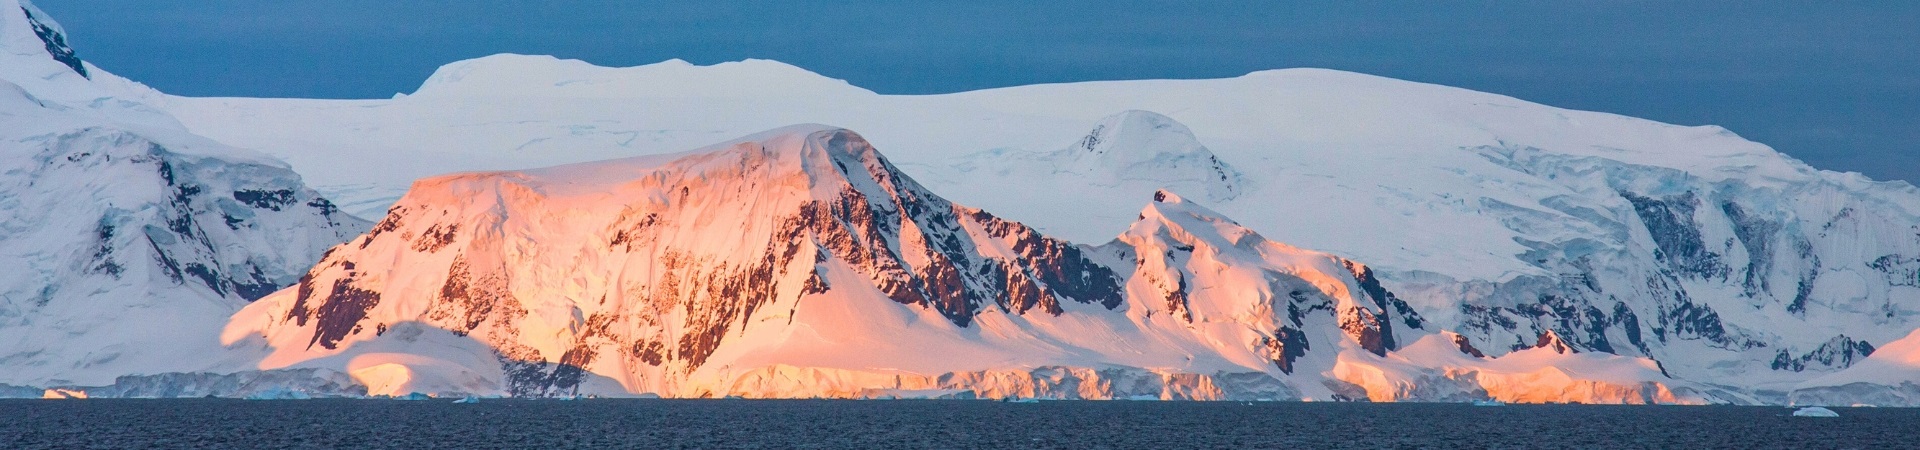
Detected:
left=0, top=400, right=1920, bottom=448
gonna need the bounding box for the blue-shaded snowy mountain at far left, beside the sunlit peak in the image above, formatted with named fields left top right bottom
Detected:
left=0, top=0, right=367, bottom=387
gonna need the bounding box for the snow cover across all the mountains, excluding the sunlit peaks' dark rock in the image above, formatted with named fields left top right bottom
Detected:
left=0, top=0, right=1920, bottom=404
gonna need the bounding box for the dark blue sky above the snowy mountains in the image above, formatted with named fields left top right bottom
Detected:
left=35, top=0, right=1920, bottom=181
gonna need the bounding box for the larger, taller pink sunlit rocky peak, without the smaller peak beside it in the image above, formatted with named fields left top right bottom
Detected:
left=228, top=125, right=1121, bottom=392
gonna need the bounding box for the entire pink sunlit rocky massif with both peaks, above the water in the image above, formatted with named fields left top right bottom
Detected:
left=225, top=125, right=1705, bottom=402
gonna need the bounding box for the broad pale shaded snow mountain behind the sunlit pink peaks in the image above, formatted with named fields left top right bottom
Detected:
left=139, top=56, right=1920, bottom=402
